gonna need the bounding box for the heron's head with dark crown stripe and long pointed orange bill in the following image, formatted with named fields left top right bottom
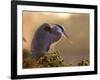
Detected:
left=53, top=24, right=72, bottom=44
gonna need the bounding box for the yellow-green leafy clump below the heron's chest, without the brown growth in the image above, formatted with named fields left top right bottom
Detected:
left=38, top=52, right=65, bottom=67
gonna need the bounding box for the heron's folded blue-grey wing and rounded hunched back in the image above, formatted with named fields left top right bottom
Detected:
left=31, top=23, right=51, bottom=53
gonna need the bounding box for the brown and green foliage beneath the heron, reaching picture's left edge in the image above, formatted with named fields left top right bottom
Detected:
left=23, top=49, right=66, bottom=68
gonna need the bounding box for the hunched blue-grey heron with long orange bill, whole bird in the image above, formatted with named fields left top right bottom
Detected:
left=31, top=23, right=71, bottom=60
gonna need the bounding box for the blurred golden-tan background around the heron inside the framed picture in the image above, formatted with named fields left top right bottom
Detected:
left=22, top=11, right=89, bottom=65
